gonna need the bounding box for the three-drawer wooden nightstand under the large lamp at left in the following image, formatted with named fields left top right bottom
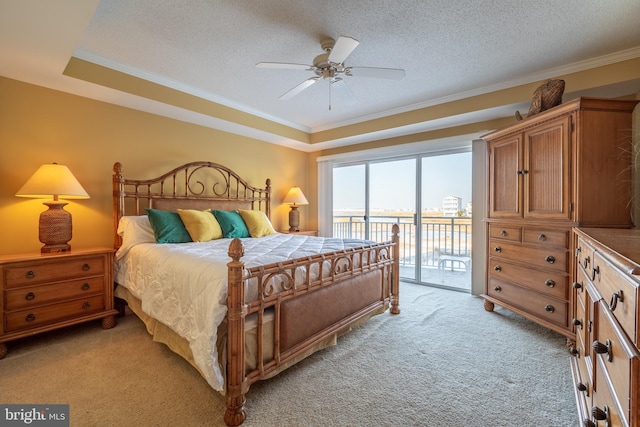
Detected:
left=0, top=248, right=118, bottom=359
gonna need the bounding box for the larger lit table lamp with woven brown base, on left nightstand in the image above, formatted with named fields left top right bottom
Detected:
left=16, top=163, right=89, bottom=253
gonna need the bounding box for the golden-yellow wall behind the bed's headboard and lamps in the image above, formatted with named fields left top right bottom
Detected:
left=0, top=77, right=317, bottom=254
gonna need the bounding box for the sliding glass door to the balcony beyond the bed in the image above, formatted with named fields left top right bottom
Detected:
left=333, top=151, right=471, bottom=291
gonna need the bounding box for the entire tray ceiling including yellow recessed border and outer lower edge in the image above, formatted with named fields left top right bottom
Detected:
left=0, top=0, right=640, bottom=151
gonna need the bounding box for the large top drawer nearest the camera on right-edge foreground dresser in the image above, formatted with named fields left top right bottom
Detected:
left=592, top=252, right=638, bottom=342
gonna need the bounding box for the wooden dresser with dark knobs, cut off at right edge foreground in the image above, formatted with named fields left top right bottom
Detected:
left=570, top=228, right=640, bottom=427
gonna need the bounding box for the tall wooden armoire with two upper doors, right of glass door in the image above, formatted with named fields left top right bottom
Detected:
left=482, top=98, right=638, bottom=340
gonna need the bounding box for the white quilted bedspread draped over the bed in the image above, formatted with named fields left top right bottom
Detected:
left=115, top=234, right=371, bottom=390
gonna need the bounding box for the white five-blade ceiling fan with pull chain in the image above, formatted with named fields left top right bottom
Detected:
left=256, top=36, right=404, bottom=109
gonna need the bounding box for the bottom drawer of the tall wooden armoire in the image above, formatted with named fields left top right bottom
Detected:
left=487, top=276, right=569, bottom=328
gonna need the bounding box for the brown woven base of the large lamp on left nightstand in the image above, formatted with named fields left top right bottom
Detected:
left=38, top=201, right=71, bottom=254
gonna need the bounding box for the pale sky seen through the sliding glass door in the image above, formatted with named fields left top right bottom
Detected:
left=333, top=152, right=472, bottom=210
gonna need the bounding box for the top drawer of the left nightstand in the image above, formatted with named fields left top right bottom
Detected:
left=4, top=256, right=105, bottom=288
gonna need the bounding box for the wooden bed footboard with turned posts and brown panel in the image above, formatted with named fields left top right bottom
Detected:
left=224, top=225, right=400, bottom=426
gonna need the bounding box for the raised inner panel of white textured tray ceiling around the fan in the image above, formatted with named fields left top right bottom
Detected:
left=76, top=0, right=640, bottom=131
